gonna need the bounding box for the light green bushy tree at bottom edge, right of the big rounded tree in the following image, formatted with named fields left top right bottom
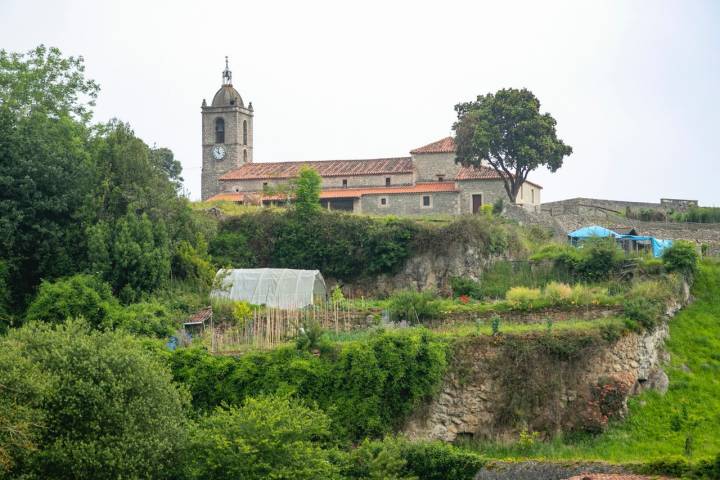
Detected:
left=188, top=397, right=338, bottom=480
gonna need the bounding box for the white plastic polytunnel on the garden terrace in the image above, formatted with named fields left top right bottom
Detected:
left=210, top=268, right=327, bottom=308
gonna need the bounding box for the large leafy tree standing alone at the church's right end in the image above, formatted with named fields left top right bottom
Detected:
left=453, top=88, right=572, bottom=203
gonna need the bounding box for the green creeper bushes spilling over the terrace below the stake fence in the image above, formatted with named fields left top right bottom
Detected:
left=170, top=332, right=446, bottom=439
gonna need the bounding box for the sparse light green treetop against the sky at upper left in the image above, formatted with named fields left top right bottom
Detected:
left=0, top=45, right=100, bottom=122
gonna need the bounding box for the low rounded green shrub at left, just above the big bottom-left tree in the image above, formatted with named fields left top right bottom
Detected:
left=26, top=274, right=118, bottom=327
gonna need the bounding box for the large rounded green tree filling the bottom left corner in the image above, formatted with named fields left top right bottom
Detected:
left=0, top=321, right=188, bottom=480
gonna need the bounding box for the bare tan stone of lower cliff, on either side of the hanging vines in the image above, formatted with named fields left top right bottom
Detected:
left=404, top=288, right=689, bottom=442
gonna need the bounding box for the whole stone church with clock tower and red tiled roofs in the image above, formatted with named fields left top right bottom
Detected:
left=202, top=58, right=542, bottom=215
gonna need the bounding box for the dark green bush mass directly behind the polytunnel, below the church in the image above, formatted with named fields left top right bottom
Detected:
left=210, top=211, right=418, bottom=279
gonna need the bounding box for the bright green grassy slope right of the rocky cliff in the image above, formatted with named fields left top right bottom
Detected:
left=466, top=263, right=720, bottom=462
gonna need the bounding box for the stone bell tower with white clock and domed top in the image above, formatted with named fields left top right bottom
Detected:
left=201, top=57, right=253, bottom=200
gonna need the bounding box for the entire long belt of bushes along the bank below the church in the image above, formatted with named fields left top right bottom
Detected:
left=210, top=210, right=521, bottom=280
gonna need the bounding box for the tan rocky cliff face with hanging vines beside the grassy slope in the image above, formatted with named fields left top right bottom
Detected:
left=404, top=289, right=687, bottom=441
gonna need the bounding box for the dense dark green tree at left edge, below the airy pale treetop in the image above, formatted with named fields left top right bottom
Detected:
left=0, top=106, right=92, bottom=308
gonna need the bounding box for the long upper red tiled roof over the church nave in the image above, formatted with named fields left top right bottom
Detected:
left=220, top=157, right=413, bottom=180
